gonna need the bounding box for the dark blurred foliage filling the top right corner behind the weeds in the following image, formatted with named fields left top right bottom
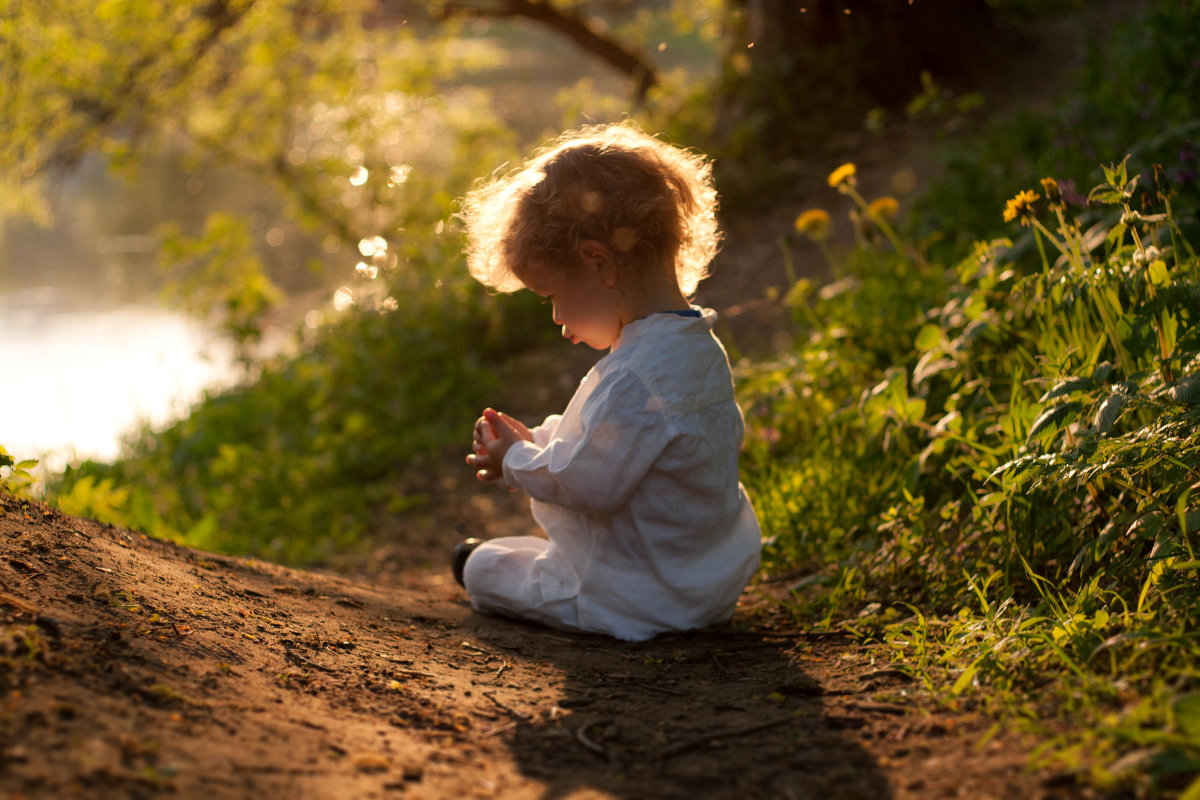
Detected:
left=913, top=0, right=1200, bottom=252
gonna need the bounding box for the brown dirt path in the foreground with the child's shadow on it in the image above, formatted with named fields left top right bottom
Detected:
left=0, top=498, right=1086, bottom=799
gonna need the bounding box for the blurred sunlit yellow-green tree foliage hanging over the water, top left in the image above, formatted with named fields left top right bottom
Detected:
left=0, top=0, right=528, bottom=316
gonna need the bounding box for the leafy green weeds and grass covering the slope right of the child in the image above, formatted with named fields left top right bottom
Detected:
left=740, top=155, right=1200, bottom=777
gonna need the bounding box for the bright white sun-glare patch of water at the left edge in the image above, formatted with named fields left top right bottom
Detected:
left=0, top=292, right=236, bottom=470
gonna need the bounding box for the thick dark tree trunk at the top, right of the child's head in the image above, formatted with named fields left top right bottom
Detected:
left=718, top=0, right=995, bottom=164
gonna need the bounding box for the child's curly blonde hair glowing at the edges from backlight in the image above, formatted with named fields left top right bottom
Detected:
left=460, top=122, right=721, bottom=296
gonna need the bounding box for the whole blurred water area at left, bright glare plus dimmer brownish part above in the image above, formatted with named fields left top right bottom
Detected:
left=0, top=155, right=313, bottom=470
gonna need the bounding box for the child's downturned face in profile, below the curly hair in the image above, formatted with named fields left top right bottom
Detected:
left=520, top=264, right=628, bottom=350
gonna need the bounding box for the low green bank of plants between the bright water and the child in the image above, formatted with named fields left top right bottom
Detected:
left=56, top=225, right=547, bottom=563
